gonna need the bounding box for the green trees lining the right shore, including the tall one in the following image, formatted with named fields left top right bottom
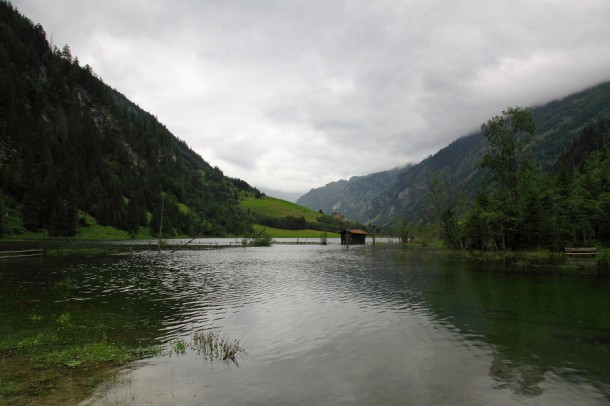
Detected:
left=429, top=108, right=610, bottom=250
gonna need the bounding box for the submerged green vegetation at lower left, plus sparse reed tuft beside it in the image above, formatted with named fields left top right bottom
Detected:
left=0, top=277, right=245, bottom=404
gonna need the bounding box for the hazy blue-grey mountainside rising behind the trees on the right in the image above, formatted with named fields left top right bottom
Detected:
left=297, top=83, right=610, bottom=226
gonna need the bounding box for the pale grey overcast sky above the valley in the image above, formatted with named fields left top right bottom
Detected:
left=12, top=0, right=610, bottom=196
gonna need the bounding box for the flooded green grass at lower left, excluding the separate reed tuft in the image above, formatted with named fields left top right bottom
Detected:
left=0, top=264, right=161, bottom=405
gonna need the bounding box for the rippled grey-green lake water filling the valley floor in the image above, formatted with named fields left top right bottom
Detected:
left=0, top=241, right=610, bottom=405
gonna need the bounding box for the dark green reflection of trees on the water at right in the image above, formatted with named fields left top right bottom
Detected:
left=414, top=261, right=610, bottom=396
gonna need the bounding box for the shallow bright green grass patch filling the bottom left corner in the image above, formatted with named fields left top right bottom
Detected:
left=0, top=312, right=161, bottom=405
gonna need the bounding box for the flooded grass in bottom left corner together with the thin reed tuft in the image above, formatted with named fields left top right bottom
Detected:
left=0, top=320, right=245, bottom=405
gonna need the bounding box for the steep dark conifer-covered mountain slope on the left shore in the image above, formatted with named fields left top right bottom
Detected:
left=0, top=1, right=257, bottom=236
